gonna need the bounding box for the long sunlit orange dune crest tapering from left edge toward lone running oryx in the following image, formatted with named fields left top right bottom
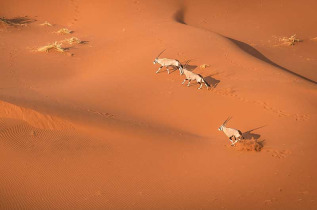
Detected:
left=0, top=101, right=198, bottom=140
